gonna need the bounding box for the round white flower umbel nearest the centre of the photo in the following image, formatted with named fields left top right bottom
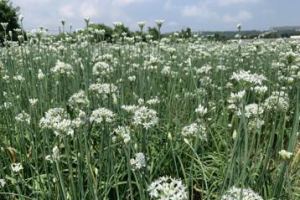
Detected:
left=133, top=106, right=158, bottom=129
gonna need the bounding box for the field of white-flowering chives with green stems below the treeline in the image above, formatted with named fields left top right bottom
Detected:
left=0, top=21, right=300, bottom=200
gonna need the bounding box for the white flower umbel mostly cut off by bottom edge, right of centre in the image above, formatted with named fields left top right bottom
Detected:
left=221, top=187, right=263, bottom=200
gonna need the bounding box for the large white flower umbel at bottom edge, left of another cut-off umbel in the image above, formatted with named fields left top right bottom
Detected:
left=148, top=176, right=188, bottom=200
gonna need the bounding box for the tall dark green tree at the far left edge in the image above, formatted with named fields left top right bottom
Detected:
left=0, top=0, right=20, bottom=42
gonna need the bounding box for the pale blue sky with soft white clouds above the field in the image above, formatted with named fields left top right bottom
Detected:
left=12, top=0, right=300, bottom=33
